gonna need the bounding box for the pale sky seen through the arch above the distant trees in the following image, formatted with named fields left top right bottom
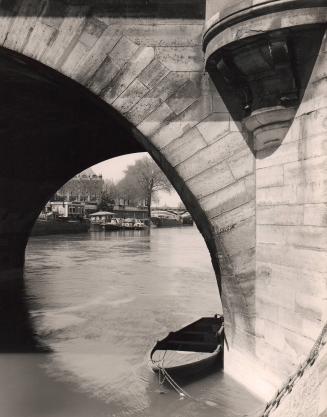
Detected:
left=92, top=152, right=181, bottom=207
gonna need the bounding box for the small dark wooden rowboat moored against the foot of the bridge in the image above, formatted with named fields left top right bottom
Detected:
left=150, top=315, right=224, bottom=377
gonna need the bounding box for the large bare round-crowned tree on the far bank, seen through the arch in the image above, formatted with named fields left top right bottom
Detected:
left=117, top=156, right=172, bottom=218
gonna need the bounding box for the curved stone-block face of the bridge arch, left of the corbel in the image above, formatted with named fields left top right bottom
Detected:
left=0, top=1, right=255, bottom=352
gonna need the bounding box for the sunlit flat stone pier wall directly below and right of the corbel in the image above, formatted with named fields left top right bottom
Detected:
left=256, top=31, right=327, bottom=384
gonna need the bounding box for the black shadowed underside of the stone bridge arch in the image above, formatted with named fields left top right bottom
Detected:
left=0, top=48, right=221, bottom=346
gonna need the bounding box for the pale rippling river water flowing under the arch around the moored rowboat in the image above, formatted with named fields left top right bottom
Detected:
left=0, top=227, right=259, bottom=417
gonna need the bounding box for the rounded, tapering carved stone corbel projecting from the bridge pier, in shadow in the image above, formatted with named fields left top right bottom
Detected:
left=203, top=0, right=327, bottom=155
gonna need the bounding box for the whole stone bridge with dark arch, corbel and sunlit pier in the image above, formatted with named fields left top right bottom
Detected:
left=0, top=0, right=327, bottom=416
